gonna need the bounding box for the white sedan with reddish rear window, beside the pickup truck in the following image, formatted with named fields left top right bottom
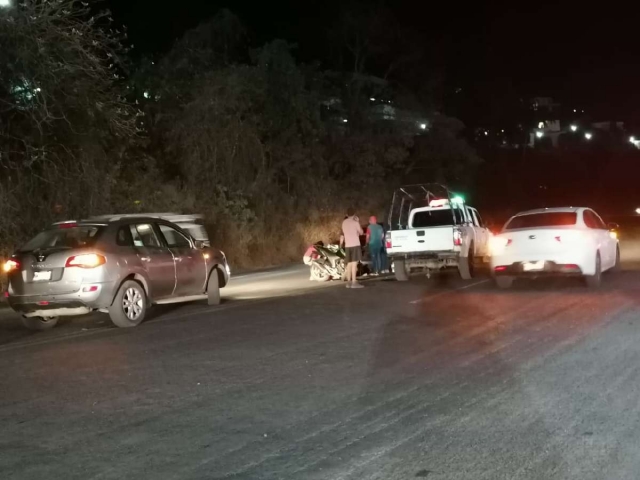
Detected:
left=491, top=207, right=620, bottom=288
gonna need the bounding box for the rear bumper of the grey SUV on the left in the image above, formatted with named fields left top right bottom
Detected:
left=7, top=282, right=116, bottom=316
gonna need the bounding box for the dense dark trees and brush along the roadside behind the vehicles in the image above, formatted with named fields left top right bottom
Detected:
left=0, top=0, right=479, bottom=266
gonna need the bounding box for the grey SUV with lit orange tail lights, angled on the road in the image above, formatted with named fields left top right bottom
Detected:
left=4, top=214, right=230, bottom=330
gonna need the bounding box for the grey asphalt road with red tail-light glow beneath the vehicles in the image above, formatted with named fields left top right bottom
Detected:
left=0, top=242, right=640, bottom=480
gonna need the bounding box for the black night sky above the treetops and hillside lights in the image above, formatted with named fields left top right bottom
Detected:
left=105, top=0, right=640, bottom=125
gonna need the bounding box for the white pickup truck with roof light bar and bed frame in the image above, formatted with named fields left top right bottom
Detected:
left=385, top=184, right=491, bottom=281
